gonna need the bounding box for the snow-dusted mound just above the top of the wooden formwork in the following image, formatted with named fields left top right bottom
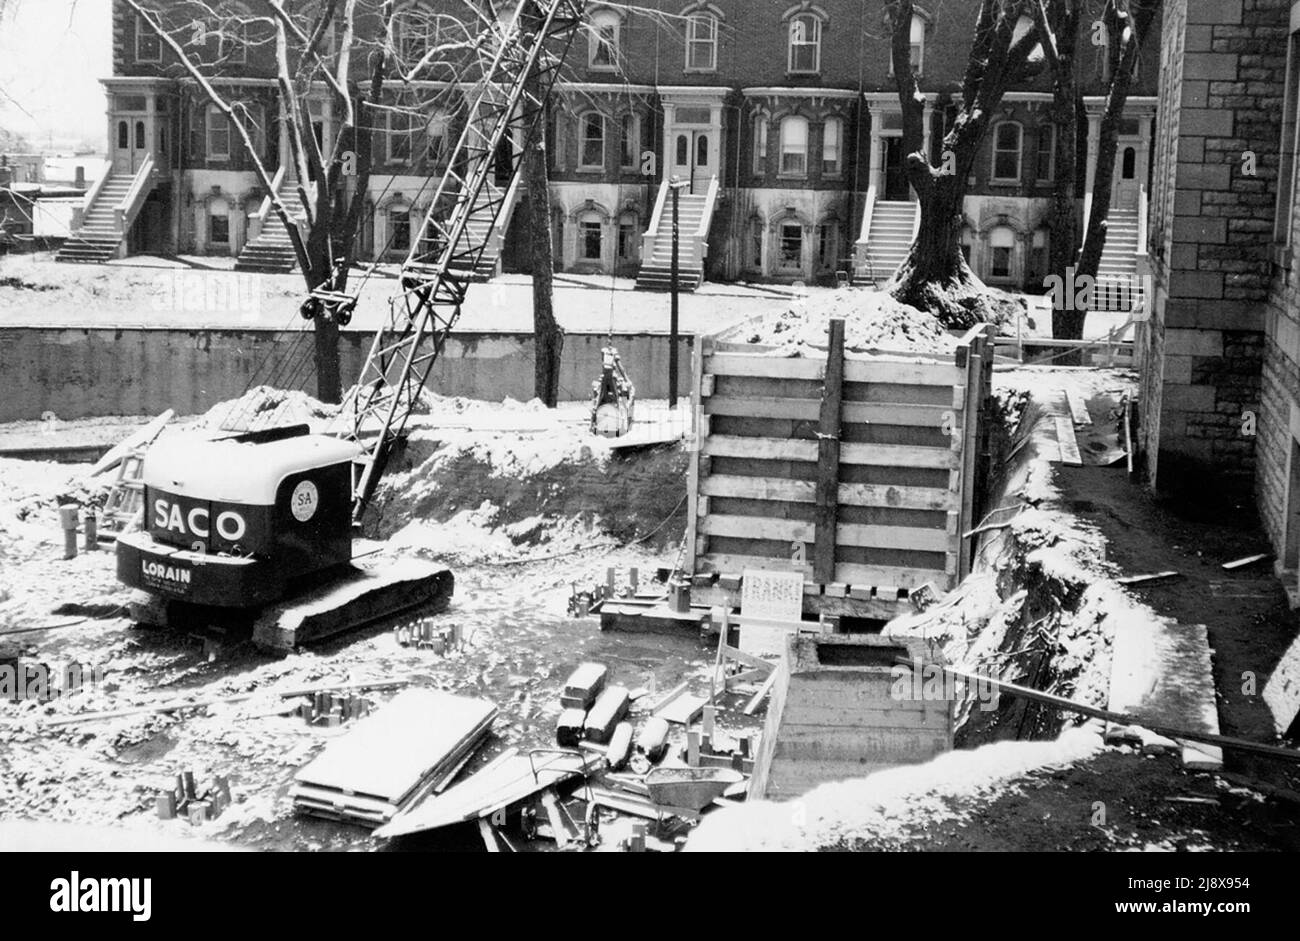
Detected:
left=722, top=287, right=957, bottom=356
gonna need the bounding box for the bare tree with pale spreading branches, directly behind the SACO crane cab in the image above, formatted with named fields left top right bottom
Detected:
left=124, top=0, right=488, bottom=402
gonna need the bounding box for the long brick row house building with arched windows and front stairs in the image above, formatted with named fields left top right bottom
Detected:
left=65, top=0, right=1157, bottom=287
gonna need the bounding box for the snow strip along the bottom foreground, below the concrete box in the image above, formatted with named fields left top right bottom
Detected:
left=686, top=728, right=1102, bottom=853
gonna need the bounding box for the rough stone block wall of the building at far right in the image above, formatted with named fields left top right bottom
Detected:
left=1139, top=0, right=1290, bottom=496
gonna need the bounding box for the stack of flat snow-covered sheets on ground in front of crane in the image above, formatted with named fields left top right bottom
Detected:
left=290, top=689, right=497, bottom=827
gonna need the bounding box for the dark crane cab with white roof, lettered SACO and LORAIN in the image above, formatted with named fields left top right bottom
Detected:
left=117, top=425, right=359, bottom=608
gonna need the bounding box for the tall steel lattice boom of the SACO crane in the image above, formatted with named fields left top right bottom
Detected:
left=343, top=0, right=585, bottom=522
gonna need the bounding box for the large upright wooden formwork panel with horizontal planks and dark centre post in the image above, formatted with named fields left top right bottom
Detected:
left=688, top=321, right=995, bottom=617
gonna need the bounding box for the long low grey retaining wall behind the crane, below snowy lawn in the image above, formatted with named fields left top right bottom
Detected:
left=0, top=328, right=694, bottom=421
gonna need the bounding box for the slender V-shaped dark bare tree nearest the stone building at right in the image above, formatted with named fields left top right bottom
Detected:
left=1030, top=0, right=1160, bottom=339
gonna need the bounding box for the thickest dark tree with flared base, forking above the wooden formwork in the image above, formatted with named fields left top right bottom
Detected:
left=885, top=0, right=1041, bottom=328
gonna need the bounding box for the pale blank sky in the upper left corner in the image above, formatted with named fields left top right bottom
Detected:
left=0, top=0, right=113, bottom=149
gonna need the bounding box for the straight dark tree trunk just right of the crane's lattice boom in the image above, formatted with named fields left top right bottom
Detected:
left=524, top=63, right=564, bottom=408
